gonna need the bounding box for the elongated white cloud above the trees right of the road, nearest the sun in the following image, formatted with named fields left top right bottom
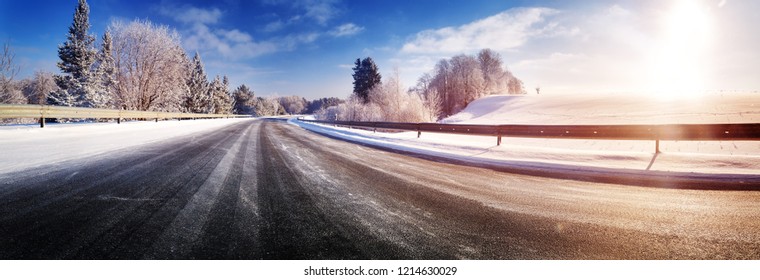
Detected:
left=401, top=8, right=562, bottom=54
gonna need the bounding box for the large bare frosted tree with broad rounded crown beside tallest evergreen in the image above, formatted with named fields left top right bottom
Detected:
left=108, top=20, right=187, bottom=111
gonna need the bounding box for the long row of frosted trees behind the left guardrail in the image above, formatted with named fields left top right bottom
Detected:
left=0, top=0, right=342, bottom=119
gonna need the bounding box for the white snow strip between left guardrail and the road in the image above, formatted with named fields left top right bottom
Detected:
left=0, top=118, right=251, bottom=174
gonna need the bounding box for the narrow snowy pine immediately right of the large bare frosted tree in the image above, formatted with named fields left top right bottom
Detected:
left=184, top=52, right=211, bottom=113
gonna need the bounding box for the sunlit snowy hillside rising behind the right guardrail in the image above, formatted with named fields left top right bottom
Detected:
left=441, top=93, right=760, bottom=124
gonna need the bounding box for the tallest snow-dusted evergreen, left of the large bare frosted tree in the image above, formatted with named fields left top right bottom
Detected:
left=49, top=0, right=97, bottom=107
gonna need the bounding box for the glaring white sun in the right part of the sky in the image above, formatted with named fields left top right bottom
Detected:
left=649, top=0, right=713, bottom=98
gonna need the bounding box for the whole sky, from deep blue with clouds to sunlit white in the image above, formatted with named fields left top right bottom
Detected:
left=0, top=0, right=760, bottom=99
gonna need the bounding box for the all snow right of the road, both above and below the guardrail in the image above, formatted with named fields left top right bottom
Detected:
left=291, top=93, right=760, bottom=176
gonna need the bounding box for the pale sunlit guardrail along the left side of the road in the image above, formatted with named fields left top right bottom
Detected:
left=0, top=104, right=250, bottom=127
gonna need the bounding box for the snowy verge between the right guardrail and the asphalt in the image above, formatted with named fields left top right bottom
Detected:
left=290, top=120, right=760, bottom=175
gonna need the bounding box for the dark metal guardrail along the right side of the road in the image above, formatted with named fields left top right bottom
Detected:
left=299, top=118, right=760, bottom=153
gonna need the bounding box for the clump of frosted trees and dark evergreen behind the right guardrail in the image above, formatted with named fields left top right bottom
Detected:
left=316, top=49, right=526, bottom=122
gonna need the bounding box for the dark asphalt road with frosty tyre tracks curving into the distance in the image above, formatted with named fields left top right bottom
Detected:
left=0, top=120, right=760, bottom=259
